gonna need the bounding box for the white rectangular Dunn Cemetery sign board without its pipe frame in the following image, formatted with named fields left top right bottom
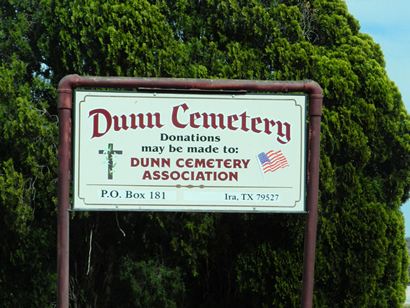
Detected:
left=73, top=90, right=306, bottom=212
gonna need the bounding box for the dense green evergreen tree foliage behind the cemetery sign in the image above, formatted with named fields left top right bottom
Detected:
left=0, top=0, right=410, bottom=307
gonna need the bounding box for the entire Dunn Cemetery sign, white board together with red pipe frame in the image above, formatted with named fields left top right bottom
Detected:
left=57, top=75, right=322, bottom=308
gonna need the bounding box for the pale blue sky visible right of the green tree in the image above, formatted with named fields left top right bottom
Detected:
left=346, top=0, right=410, bottom=237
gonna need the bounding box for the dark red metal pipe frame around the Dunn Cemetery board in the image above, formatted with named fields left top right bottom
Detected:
left=57, top=75, right=323, bottom=308
